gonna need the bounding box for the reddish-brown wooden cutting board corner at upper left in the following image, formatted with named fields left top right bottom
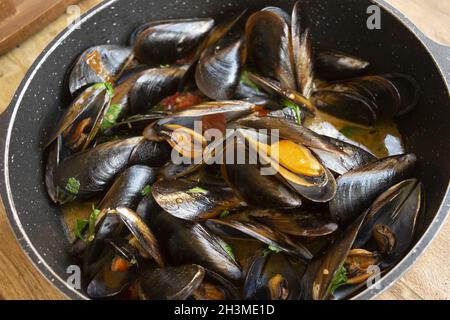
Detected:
left=0, top=0, right=79, bottom=55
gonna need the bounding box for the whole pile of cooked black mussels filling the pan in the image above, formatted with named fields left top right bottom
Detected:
left=46, top=3, right=424, bottom=299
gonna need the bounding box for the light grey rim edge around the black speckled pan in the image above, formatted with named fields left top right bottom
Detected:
left=1, top=0, right=450, bottom=299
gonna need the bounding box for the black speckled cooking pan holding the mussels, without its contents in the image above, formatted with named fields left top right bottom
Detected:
left=0, top=0, right=450, bottom=299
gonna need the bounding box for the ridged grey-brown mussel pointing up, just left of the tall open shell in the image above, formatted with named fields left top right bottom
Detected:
left=195, top=39, right=245, bottom=100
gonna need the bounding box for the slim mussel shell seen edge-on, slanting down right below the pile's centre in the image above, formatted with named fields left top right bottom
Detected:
left=206, top=212, right=312, bottom=260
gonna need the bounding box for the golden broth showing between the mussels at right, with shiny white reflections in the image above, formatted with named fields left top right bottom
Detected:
left=304, top=111, right=405, bottom=158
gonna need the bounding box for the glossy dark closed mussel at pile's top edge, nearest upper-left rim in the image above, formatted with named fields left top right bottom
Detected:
left=134, top=18, right=214, bottom=66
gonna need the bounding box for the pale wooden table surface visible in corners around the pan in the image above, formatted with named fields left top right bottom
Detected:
left=0, top=0, right=450, bottom=299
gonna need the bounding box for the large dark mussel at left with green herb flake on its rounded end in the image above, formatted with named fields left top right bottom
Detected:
left=55, top=137, right=170, bottom=200
